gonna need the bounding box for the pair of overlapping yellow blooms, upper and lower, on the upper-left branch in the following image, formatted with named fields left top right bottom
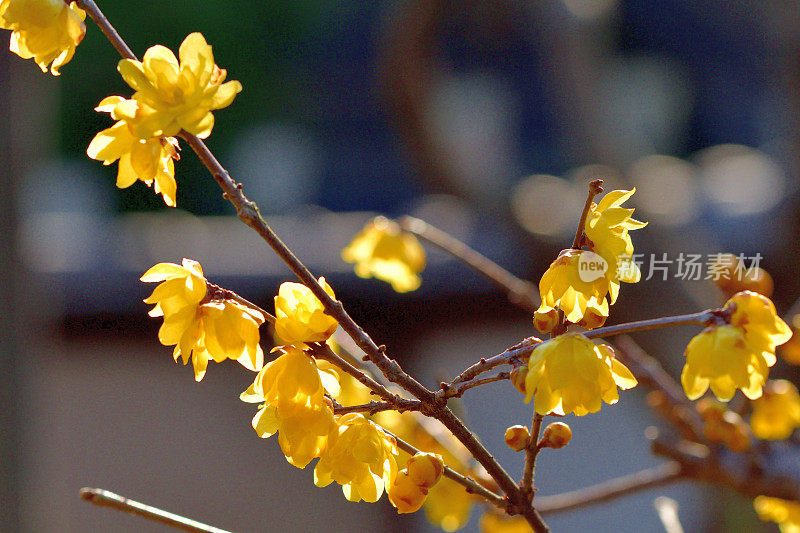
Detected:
left=86, top=32, right=242, bottom=207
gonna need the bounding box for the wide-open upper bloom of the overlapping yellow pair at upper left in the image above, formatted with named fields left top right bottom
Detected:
left=116, top=33, right=242, bottom=139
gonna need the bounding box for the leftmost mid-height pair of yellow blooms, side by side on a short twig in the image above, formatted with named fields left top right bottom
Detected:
left=141, top=259, right=264, bottom=381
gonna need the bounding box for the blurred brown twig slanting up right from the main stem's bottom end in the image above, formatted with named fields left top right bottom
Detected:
left=536, top=461, right=685, bottom=513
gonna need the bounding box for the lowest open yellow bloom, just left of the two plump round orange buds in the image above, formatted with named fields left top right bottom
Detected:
left=314, top=413, right=397, bottom=502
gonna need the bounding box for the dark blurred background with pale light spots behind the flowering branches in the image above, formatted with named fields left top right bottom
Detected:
left=0, top=0, right=800, bottom=533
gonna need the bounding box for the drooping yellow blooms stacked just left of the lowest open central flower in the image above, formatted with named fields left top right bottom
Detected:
left=240, top=346, right=336, bottom=468
